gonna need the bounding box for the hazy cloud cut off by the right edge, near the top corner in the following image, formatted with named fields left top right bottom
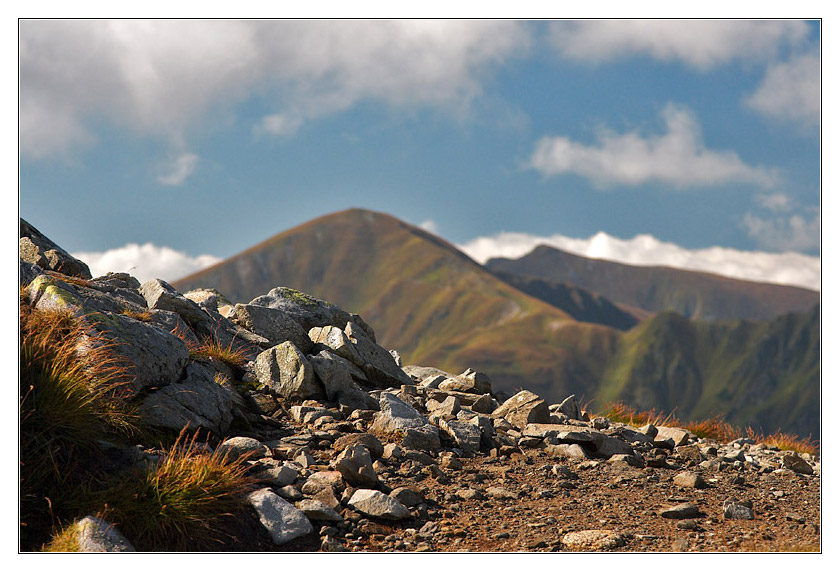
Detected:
left=746, top=52, right=820, bottom=125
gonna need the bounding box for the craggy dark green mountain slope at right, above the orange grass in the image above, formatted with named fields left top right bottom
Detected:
left=597, top=306, right=820, bottom=437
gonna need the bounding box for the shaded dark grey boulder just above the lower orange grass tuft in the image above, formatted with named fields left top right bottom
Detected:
left=139, top=364, right=233, bottom=435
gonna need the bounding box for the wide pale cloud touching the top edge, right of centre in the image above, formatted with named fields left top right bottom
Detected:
left=551, top=20, right=808, bottom=70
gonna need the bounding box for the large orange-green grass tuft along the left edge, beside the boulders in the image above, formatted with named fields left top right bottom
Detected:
left=19, top=293, right=137, bottom=548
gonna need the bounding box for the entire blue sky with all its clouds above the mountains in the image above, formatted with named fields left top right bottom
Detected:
left=19, top=20, right=821, bottom=289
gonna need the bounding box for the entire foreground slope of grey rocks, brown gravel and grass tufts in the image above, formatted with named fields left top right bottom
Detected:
left=20, top=219, right=821, bottom=552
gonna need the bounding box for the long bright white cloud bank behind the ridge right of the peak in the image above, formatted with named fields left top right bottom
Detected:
left=459, top=232, right=820, bottom=290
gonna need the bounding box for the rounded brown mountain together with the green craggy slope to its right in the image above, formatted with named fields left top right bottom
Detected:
left=173, top=209, right=819, bottom=436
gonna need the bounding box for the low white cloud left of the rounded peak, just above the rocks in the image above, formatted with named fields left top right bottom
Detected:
left=73, top=242, right=221, bottom=282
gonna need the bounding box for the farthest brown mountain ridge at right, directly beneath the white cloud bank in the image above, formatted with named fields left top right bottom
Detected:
left=487, top=246, right=820, bottom=320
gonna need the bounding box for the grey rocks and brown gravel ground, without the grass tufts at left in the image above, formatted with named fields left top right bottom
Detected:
left=20, top=221, right=821, bottom=552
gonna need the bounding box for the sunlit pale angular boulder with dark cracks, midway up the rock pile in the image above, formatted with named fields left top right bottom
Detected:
left=254, top=342, right=323, bottom=399
